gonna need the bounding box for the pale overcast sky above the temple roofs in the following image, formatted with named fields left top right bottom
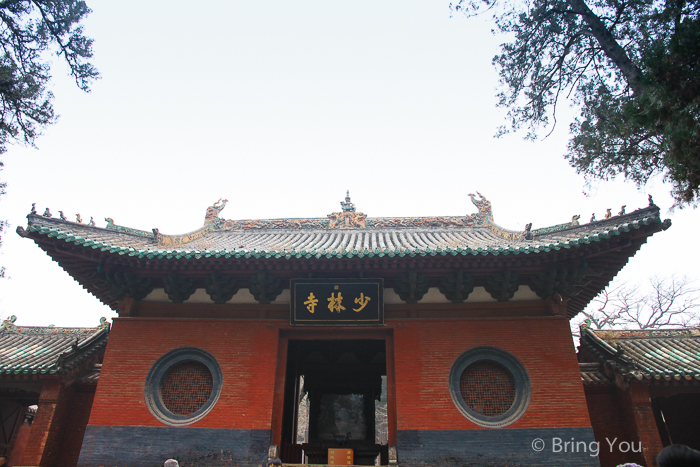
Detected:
left=0, top=0, right=700, bottom=326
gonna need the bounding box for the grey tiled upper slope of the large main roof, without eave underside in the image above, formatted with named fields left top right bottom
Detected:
left=17, top=199, right=670, bottom=259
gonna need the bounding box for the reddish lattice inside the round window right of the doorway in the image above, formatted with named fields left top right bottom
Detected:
left=459, top=360, right=515, bottom=417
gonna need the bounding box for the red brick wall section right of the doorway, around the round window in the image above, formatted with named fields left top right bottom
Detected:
left=394, top=317, right=590, bottom=430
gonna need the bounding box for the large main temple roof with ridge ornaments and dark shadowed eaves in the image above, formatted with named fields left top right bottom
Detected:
left=17, top=195, right=670, bottom=317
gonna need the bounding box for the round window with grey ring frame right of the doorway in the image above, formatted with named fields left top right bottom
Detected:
left=450, top=347, right=530, bottom=428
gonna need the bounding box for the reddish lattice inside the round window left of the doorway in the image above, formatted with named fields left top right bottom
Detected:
left=161, top=361, right=214, bottom=415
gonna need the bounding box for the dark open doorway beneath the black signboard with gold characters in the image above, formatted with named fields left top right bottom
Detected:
left=281, top=339, right=388, bottom=465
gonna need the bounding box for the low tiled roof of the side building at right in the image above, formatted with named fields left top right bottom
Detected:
left=581, top=326, right=700, bottom=382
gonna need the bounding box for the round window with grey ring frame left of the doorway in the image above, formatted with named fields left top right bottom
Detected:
left=145, top=347, right=222, bottom=426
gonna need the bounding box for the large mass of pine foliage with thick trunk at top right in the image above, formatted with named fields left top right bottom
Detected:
left=453, top=0, right=700, bottom=207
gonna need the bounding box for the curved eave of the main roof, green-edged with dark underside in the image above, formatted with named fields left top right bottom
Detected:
left=18, top=215, right=668, bottom=318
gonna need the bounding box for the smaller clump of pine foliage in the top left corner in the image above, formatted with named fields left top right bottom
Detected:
left=0, top=0, right=98, bottom=154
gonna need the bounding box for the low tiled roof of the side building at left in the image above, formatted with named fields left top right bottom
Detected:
left=0, top=316, right=109, bottom=374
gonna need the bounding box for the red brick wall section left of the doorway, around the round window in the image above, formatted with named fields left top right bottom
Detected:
left=89, top=318, right=279, bottom=429
